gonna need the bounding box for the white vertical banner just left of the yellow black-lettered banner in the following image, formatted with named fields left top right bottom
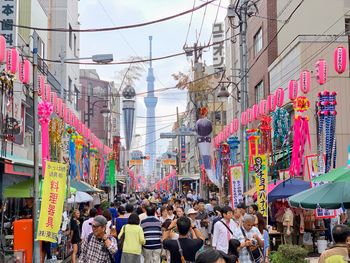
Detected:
left=230, top=164, right=243, bottom=208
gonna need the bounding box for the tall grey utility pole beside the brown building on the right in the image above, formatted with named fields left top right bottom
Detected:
left=239, top=0, right=249, bottom=190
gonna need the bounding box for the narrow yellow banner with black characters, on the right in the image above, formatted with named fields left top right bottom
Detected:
left=254, top=155, right=268, bottom=216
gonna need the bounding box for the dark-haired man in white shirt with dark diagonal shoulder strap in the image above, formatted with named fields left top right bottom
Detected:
left=212, top=206, right=237, bottom=254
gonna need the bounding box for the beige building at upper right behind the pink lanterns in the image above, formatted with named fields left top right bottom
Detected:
left=268, top=0, right=350, bottom=166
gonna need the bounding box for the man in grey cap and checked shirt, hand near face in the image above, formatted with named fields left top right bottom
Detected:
left=78, top=216, right=118, bottom=263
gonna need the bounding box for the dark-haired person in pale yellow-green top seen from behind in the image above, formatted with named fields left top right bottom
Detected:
left=118, top=214, right=146, bottom=263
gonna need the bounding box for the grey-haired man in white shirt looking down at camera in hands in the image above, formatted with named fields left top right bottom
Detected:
left=235, top=214, right=264, bottom=263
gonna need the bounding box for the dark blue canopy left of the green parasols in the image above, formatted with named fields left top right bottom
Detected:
left=268, top=178, right=311, bottom=202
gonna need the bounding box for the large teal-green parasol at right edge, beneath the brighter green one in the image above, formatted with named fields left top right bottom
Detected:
left=288, top=183, right=350, bottom=209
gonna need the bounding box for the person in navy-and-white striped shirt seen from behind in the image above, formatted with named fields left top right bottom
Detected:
left=141, top=206, right=162, bottom=263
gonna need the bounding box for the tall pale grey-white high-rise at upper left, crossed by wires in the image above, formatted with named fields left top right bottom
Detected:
left=40, top=0, right=80, bottom=114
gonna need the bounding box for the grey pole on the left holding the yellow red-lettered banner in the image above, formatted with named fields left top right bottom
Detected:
left=33, top=31, right=40, bottom=263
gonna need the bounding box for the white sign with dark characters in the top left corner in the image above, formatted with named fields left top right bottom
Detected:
left=0, top=0, right=17, bottom=47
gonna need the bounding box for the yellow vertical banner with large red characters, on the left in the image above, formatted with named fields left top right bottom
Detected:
left=37, top=162, right=67, bottom=242
